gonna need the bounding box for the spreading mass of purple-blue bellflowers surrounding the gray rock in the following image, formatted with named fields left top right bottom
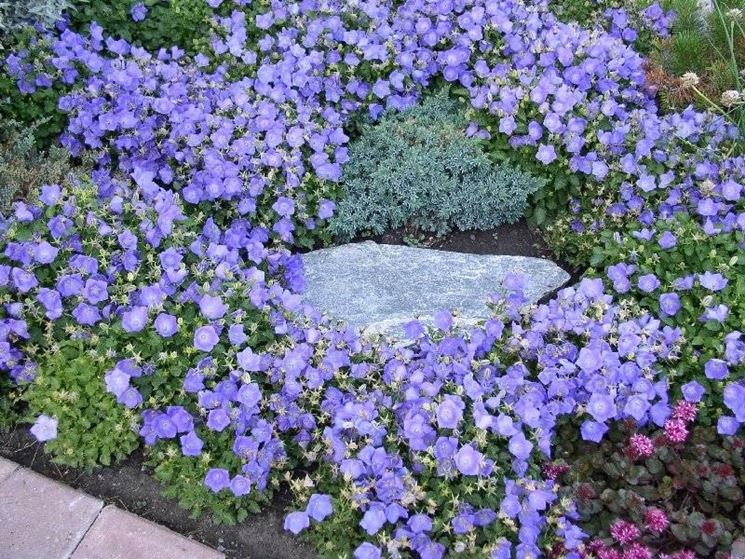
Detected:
left=0, top=0, right=745, bottom=559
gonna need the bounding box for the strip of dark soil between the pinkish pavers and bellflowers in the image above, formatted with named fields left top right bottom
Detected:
left=0, top=427, right=315, bottom=559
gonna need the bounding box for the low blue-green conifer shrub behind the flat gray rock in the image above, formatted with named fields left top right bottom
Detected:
left=330, top=91, right=544, bottom=240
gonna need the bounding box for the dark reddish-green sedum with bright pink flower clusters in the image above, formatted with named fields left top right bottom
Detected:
left=554, top=402, right=745, bottom=557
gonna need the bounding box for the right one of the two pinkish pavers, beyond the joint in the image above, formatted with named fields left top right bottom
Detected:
left=71, top=505, right=225, bottom=559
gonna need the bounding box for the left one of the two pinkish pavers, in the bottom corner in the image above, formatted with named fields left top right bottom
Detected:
left=0, top=468, right=103, bottom=559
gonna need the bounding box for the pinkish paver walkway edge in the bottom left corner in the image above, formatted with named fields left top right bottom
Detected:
left=0, top=458, right=225, bottom=559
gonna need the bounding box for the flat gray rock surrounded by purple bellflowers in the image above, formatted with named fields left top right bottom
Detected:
left=303, top=241, right=569, bottom=336
